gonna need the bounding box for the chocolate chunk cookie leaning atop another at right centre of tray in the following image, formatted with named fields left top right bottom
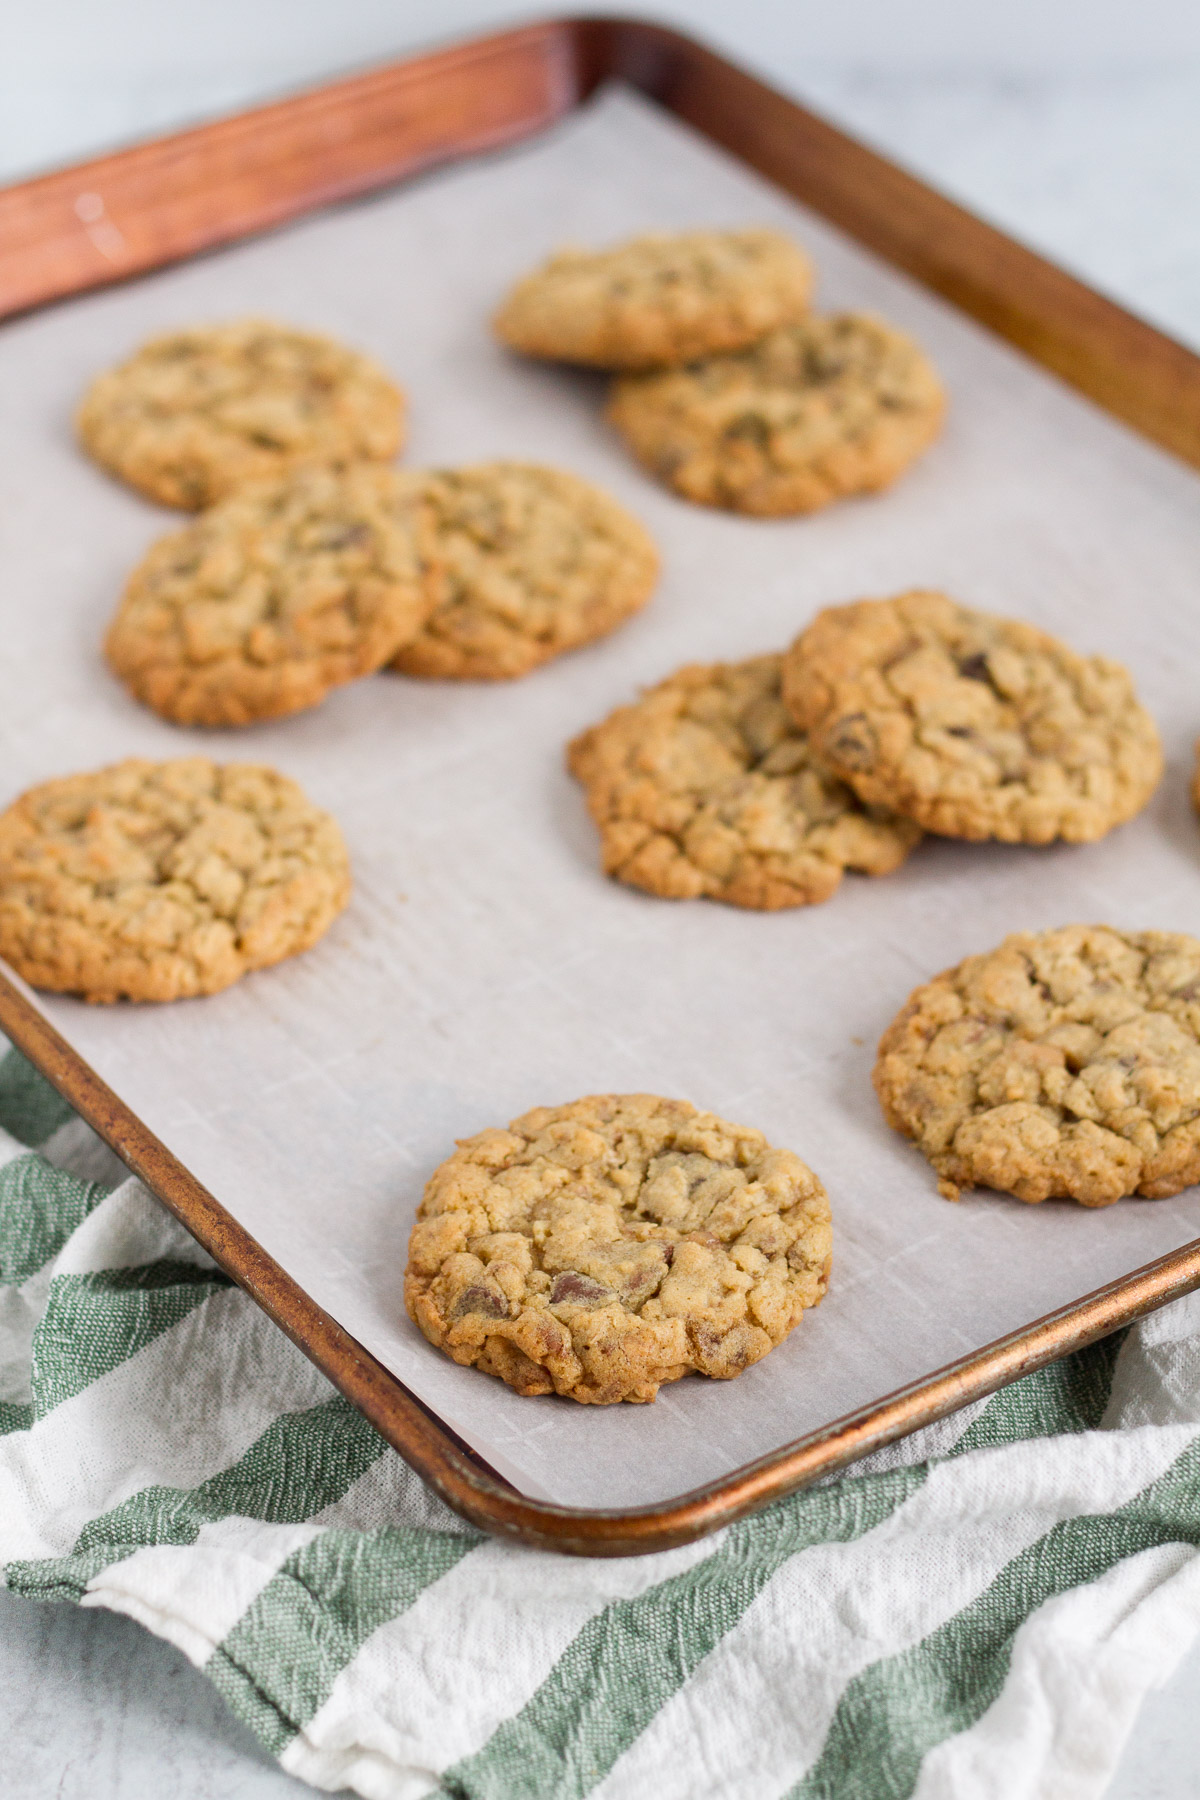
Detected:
left=783, top=590, right=1162, bottom=844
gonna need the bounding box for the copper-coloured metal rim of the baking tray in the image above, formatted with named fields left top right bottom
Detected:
left=0, top=18, right=1200, bottom=1555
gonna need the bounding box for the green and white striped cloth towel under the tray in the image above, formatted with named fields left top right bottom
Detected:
left=0, top=1051, right=1200, bottom=1800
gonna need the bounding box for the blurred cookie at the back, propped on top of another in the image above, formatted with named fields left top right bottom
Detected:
left=495, top=230, right=813, bottom=369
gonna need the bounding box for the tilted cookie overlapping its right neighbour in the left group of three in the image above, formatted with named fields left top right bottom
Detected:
left=104, top=463, right=434, bottom=725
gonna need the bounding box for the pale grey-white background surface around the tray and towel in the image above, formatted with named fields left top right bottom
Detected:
left=0, top=0, right=1200, bottom=1800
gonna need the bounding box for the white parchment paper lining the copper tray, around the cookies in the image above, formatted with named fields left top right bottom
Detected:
left=0, top=90, right=1200, bottom=1507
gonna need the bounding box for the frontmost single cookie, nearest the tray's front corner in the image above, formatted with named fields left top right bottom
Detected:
left=405, top=1094, right=831, bottom=1406
